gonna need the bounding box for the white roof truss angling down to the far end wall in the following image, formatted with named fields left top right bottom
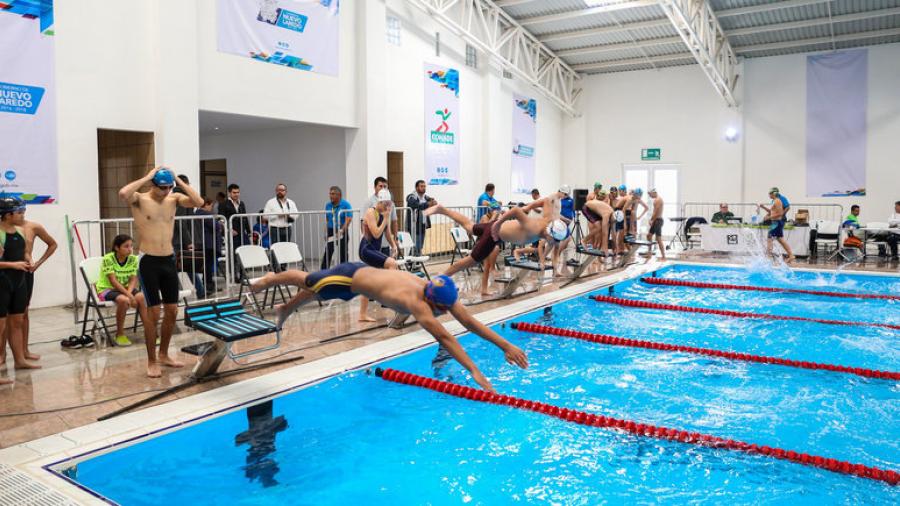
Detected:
left=659, top=0, right=737, bottom=106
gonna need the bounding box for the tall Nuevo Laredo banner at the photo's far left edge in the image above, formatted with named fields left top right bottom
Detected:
left=0, top=0, right=59, bottom=204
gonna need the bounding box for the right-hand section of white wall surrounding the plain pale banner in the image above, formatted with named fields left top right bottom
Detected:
left=744, top=44, right=900, bottom=218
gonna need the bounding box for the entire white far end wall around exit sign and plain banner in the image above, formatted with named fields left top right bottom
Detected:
left=563, top=44, right=900, bottom=221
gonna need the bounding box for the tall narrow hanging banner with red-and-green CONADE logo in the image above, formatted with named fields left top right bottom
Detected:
left=425, top=63, right=459, bottom=185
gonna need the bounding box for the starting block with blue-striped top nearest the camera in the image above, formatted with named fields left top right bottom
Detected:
left=184, top=298, right=281, bottom=379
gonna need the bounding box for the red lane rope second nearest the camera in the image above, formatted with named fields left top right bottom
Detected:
left=512, top=322, right=900, bottom=380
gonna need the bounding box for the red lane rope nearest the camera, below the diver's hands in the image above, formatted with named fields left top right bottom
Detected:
left=375, top=368, right=900, bottom=485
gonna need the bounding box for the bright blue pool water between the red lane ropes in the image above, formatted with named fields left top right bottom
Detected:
left=59, top=265, right=900, bottom=506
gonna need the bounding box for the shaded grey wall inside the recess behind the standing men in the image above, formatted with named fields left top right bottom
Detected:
left=200, top=125, right=346, bottom=213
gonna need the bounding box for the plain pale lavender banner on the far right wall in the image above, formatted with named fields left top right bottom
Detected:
left=806, top=49, right=869, bottom=197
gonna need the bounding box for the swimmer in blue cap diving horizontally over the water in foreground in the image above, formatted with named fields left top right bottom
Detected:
left=250, top=262, right=528, bottom=391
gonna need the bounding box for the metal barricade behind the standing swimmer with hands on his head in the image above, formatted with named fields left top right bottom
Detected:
left=69, top=214, right=231, bottom=323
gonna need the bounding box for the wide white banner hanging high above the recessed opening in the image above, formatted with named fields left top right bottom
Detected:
left=218, top=0, right=341, bottom=76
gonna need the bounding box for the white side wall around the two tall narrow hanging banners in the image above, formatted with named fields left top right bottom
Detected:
left=382, top=0, right=562, bottom=205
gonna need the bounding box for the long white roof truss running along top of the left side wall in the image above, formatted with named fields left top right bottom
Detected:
left=407, top=0, right=581, bottom=116
